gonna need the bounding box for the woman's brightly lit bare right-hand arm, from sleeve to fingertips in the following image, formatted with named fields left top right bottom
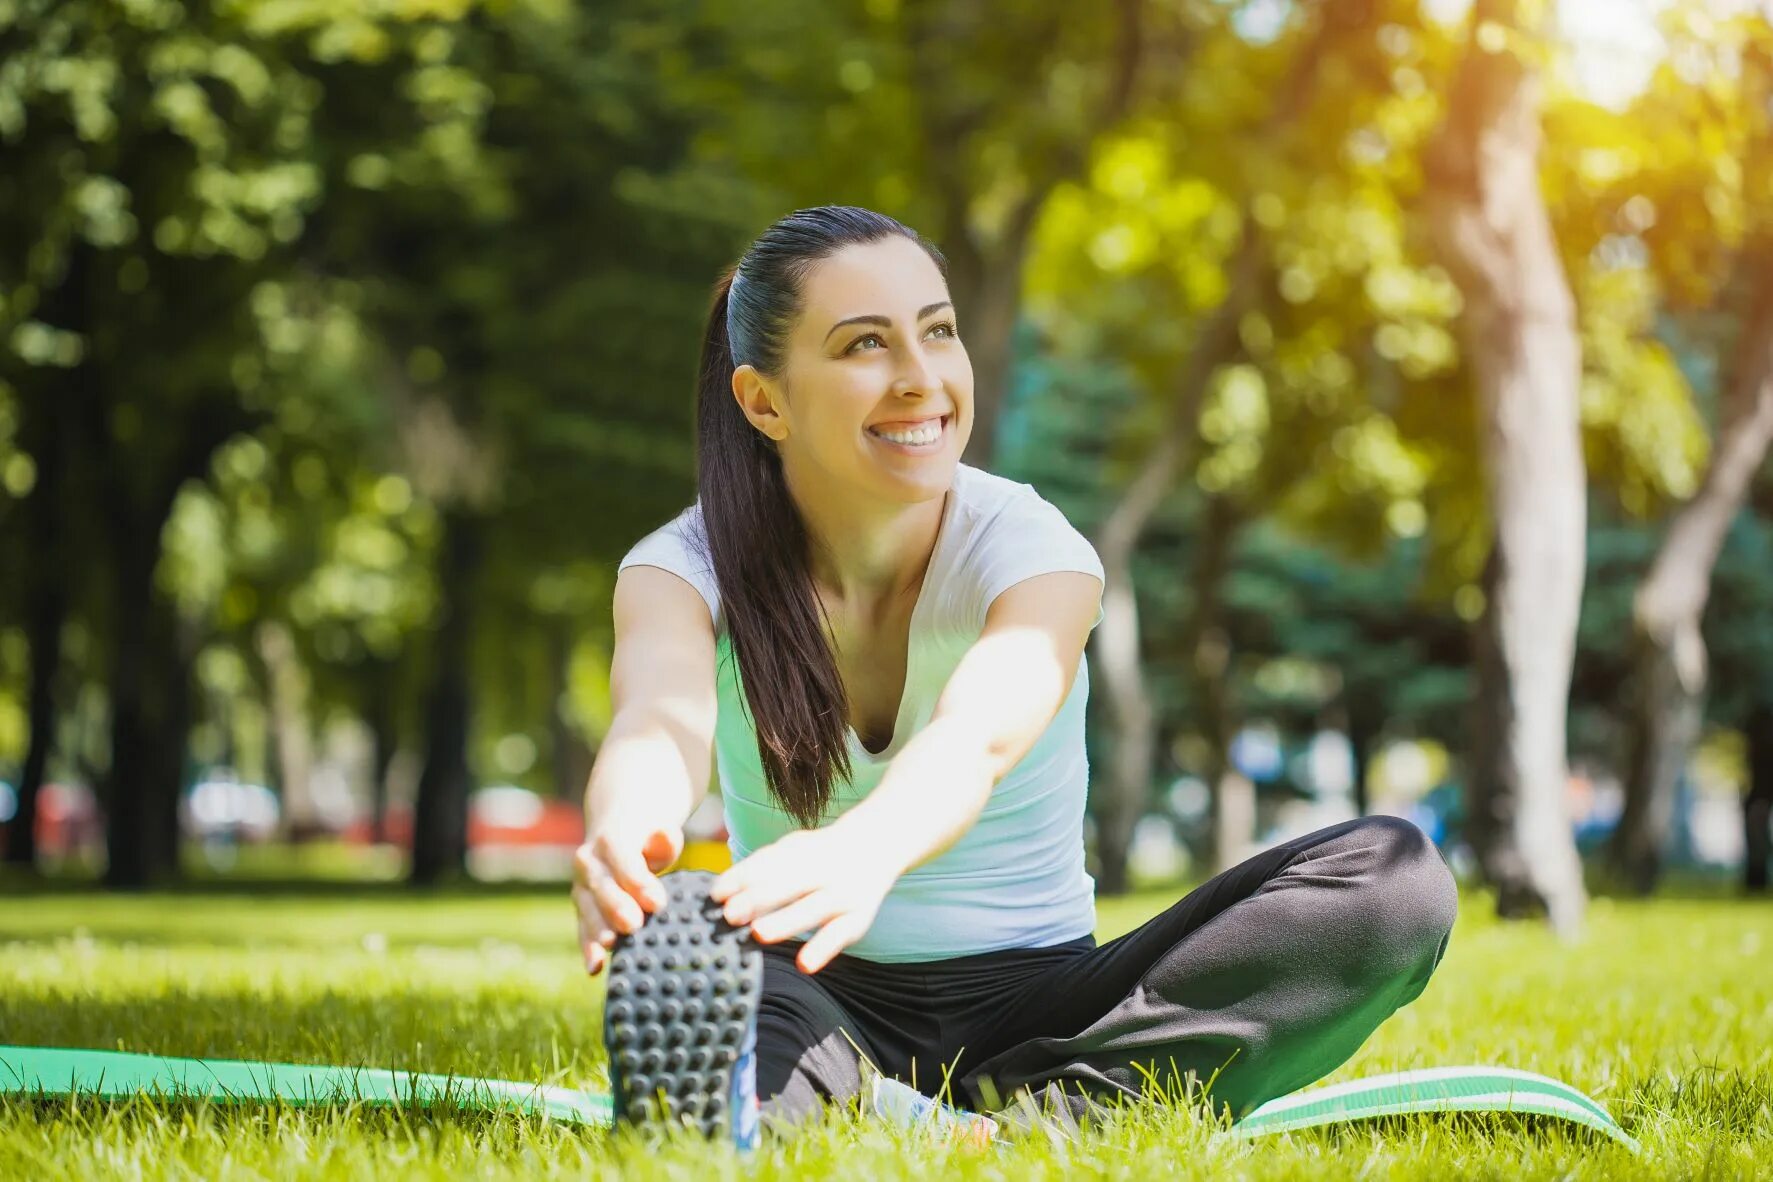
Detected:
left=713, top=571, right=1103, bottom=973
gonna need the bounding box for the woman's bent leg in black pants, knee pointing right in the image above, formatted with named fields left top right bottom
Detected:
left=961, top=817, right=1456, bottom=1116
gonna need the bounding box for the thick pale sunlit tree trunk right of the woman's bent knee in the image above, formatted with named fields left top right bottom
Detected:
left=1424, top=0, right=1587, bottom=936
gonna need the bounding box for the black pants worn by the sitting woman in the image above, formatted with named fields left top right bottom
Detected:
left=757, top=817, right=1456, bottom=1127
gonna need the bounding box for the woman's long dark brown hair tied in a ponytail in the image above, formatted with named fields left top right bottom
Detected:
left=695, top=206, right=949, bottom=828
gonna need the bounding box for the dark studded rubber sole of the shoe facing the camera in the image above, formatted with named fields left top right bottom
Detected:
left=603, top=870, right=764, bottom=1136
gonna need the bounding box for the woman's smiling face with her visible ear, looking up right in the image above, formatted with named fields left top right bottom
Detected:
left=732, top=234, right=973, bottom=502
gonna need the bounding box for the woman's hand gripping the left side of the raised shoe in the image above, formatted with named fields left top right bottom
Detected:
left=573, top=815, right=683, bottom=975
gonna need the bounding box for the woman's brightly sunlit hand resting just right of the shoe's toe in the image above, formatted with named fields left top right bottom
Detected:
left=709, top=824, right=902, bottom=973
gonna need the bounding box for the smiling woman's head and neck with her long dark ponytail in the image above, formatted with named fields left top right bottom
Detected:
left=712, top=209, right=973, bottom=824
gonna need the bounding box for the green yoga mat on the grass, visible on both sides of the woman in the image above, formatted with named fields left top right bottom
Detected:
left=0, top=1047, right=1638, bottom=1152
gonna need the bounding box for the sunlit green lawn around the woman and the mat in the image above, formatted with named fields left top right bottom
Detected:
left=0, top=884, right=1773, bottom=1182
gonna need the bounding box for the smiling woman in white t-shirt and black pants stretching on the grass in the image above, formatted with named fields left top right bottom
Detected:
left=573, top=206, right=1454, bottom=1148
